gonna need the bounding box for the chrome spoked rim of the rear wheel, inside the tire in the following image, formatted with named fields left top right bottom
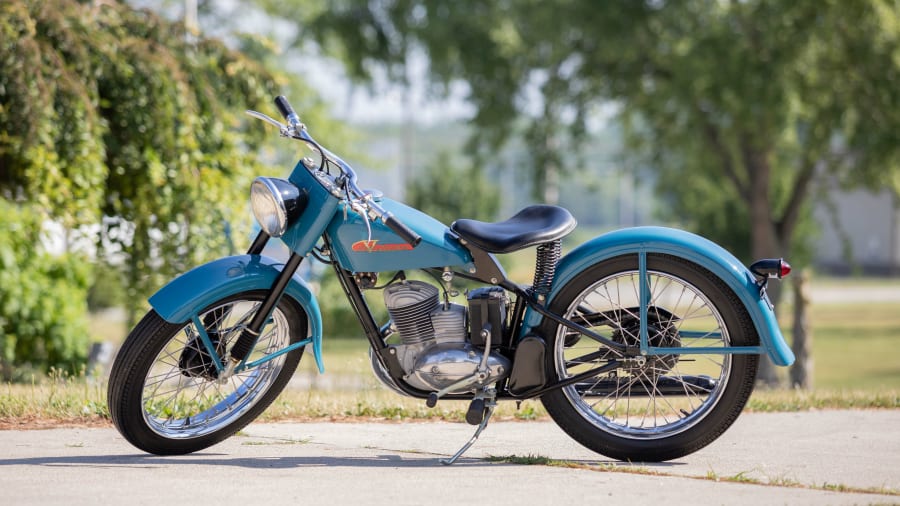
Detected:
left=554, top=270, right=732, bottom=440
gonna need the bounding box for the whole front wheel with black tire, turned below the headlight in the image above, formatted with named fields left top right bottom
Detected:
left=108, top=291, right=307, bottom=455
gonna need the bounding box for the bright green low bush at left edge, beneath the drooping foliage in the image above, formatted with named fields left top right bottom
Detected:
left=0, top=199, right=90, bottom=381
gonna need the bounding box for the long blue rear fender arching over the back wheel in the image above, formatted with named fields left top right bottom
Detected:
left=522, top=227, right=794, bottom=366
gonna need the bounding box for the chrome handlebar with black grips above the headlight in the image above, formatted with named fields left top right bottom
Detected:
left=256, top=95, right=422, bottom=247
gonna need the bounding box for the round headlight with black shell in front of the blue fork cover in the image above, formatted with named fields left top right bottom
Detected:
left=250, top=177, right=306, bottom=237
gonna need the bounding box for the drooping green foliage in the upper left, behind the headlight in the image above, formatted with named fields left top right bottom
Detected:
left=0, top=0, right=296, bottom=372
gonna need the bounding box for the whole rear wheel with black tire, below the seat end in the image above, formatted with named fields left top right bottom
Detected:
left=542, top=254, right=759, bottom=462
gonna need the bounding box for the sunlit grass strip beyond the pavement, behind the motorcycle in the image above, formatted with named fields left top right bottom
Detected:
left=0, top=275, right=900, bottom=426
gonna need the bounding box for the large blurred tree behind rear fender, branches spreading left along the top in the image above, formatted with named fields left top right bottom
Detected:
left=270, top=0, right=900, bottom=382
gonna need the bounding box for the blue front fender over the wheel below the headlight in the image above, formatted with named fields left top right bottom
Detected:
left=150, top=255, right=325, bottom=373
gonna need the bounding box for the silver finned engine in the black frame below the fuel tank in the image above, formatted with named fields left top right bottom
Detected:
left=384, top=281, right=510, bottom=393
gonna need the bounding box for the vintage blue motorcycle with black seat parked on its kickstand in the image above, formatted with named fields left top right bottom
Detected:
left=108, top=96, right=794, bottom=464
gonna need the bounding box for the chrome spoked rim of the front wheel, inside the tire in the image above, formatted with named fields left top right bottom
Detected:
left=141, top=300, right=290, bottom=439
